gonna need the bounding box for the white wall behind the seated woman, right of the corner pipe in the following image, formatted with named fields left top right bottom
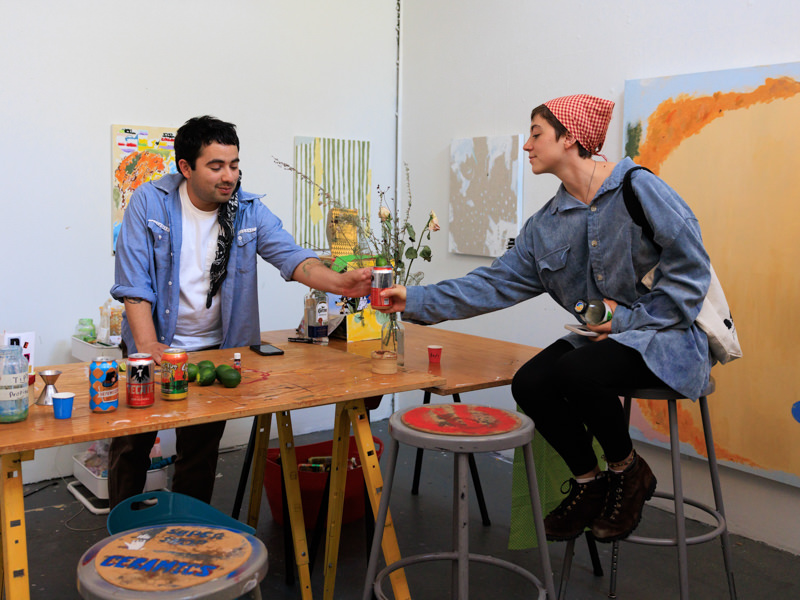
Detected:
left=400, top=0, right=800, bottom=553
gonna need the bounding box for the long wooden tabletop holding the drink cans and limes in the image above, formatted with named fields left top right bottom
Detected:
left=0, top=342, right=444, bottom=454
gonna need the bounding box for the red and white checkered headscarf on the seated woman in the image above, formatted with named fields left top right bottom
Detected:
left=544, top=94, right=614, bottom=160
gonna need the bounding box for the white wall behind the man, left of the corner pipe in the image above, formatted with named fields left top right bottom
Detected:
left=0, top=0, right=397, bottom=481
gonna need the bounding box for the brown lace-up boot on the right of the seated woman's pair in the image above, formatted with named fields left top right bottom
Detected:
left=592, top=454, right=656, bottom=542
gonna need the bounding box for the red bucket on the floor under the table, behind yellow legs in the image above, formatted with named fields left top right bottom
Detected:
left=264, top=436, right=383, bottom=529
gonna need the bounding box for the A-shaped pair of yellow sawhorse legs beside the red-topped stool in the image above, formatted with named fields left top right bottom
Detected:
left=324, top=400, right=411, bottom=600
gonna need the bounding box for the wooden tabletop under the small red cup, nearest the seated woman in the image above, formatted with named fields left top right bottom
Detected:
left=310, top=323, right=539, bottom=396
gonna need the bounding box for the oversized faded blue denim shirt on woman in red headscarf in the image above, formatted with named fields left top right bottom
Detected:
left=404, top=158, right=712, bottom=398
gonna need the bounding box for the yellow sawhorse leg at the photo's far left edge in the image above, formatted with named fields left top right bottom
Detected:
left=0, top=450, right=33, bottom=600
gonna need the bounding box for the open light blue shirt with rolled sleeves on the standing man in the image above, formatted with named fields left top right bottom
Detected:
left=111, top=175, right=317, bottom=352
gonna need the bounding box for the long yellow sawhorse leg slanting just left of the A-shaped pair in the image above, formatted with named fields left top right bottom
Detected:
left=276, top=411, right=311, bottom=600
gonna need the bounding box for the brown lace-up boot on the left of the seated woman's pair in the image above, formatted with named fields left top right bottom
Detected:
left=544, top=473, right=607, bottom=542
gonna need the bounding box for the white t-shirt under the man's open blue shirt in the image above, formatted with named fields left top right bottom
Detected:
left=172, top=181, right=222, bottom=350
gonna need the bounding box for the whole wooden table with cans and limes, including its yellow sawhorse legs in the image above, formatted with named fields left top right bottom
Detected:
left=0, top=337, right=444, bottom=600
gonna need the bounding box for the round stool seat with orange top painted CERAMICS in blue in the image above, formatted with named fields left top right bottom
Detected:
left=78, top=523, right=267, bottom=600
